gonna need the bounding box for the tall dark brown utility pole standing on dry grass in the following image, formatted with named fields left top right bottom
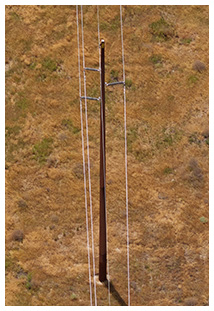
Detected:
left=99, top=40, right=106, bottom=282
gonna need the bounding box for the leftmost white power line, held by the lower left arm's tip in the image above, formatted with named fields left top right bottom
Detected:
left=76, top=5, right=92, bottom=306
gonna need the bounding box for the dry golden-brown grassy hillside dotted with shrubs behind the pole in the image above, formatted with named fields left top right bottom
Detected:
left=5, top=5, right=209, bottom=306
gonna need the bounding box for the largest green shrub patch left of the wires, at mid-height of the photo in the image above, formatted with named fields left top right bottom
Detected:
left=33, top=138, right=53, bottom=164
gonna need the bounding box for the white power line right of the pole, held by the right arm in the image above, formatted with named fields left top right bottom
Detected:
left=120, top=5, right=130, bottom=306
